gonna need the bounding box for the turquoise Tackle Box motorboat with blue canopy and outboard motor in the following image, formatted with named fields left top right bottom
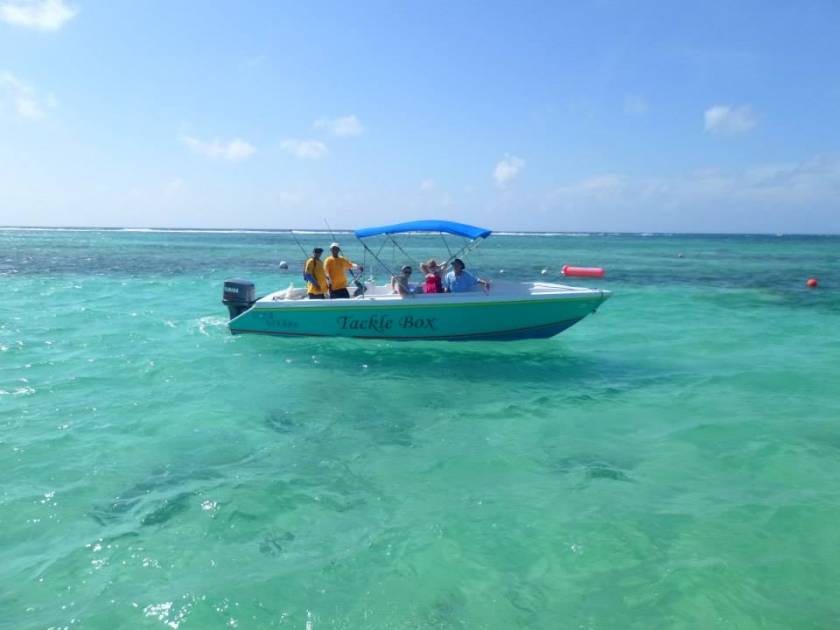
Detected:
left=222, top=220, right=610, bottom=341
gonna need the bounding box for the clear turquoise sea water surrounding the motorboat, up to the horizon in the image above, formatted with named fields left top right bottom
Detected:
left=0, top=230, right=840, bottom=630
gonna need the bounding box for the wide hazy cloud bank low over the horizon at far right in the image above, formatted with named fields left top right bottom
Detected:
left=537, top=156, right=840, bottom=232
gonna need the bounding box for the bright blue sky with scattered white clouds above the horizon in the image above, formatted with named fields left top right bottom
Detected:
left=0, top=0, right=840, bottom=233
